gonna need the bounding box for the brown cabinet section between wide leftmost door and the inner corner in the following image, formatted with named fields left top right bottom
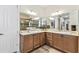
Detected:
left=33, top=32, right=45, bottom=48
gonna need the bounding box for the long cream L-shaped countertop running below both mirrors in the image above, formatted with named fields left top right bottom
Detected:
left=20, top=29, right=79, bottom=36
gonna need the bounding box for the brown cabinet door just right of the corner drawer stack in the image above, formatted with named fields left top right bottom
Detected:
left=53, top=34, right=63, bottom=50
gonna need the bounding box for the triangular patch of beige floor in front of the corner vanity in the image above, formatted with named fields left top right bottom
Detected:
left=32, top=45, right=62, bottom=53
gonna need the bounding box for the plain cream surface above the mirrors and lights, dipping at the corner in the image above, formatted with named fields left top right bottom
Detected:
left=20, top=5, right=79, bottom=17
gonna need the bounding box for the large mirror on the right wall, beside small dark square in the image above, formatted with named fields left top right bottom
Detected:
left=50, top=13, right=70, bottom=31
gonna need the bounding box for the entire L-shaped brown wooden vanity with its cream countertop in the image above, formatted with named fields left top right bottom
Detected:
left=20, top=29, right=79, bottom=53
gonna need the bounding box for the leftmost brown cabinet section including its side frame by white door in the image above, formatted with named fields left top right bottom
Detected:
left=20, top=35, right=33, bottom=53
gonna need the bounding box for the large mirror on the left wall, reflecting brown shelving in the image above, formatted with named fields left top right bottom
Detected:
left=20, top=13, right=50, bottom=30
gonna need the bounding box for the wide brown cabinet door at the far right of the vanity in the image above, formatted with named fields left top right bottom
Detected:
left=63, top=35, right=78, bottom=52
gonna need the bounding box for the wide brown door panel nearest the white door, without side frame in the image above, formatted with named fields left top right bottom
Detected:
left=22, top=35, right=33, bottom=52
